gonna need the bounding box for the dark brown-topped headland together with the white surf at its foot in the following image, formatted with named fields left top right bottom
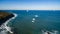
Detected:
left=0, top=12, right=17, bottom=34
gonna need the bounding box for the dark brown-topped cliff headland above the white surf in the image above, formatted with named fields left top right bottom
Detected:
left=0, top=12, right=14, bottom=26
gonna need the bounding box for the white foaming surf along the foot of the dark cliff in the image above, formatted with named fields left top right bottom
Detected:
left=0, top=13, right=17, bottom=34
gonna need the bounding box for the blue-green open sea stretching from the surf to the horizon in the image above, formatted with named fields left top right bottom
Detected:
left=2, top=10, right=60, bottom=34
